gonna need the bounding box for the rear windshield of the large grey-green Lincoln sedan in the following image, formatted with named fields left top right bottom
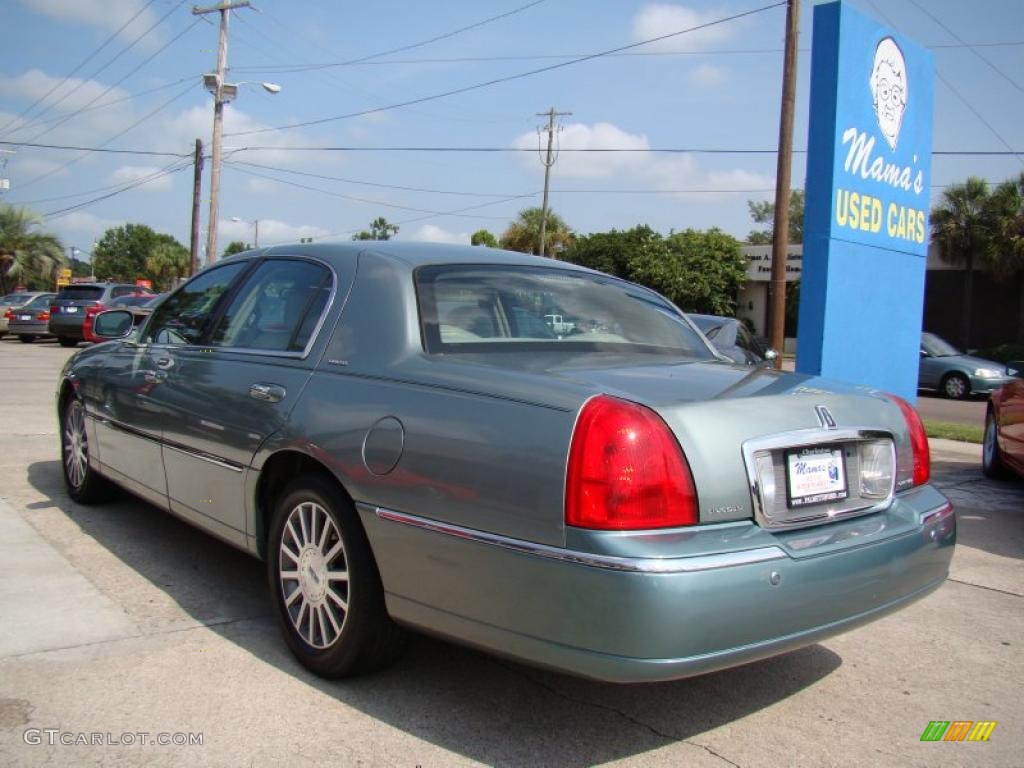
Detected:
left=416, top=265, right=713, bottom=359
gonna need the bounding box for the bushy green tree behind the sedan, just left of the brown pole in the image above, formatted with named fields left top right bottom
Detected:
left=629, top=228, right=746, bottom=315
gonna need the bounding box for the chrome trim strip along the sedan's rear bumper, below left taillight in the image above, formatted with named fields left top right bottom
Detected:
left=369, top=507, right=788, bottom=573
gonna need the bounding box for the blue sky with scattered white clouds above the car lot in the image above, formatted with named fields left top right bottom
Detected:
left=0, top=0, right=1024, bottom=264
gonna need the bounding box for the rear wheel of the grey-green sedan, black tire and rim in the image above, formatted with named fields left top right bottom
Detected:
left=266, top=474, right=406, bottom=679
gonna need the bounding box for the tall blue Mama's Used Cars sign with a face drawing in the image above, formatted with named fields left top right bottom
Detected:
left=797, top=2, right=934, bottom=401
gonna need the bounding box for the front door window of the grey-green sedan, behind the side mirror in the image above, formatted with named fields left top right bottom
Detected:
left=144, top=261, right=249, bottom=344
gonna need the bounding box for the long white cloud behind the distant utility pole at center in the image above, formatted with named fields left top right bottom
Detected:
left=513, top=123, right=774, bottom=195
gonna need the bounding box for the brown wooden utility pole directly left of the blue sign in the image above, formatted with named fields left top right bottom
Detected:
left=769, top=0, right=800, bottom=369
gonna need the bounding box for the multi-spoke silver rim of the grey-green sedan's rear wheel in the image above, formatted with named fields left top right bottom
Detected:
left=278, top=502, right=349, bottom=648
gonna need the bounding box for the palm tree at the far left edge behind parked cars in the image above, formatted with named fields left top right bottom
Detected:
left=0, top=204, right=68, bottom=295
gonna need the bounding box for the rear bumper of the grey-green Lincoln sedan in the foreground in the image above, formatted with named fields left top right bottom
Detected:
left=359, top=486, right=956, bottom=683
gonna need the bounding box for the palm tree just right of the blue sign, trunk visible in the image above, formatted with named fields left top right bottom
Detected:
left=929, top=176, right=1007, bottom=348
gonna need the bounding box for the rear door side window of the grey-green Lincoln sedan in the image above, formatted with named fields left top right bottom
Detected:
left=210, top=259, right=332, bottom=352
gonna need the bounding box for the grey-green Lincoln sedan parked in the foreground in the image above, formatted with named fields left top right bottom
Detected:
left=56, top=243, right=956, bottom=682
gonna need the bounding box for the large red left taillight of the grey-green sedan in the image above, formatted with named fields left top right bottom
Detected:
left=565, top=395, right=698, bottom=530
